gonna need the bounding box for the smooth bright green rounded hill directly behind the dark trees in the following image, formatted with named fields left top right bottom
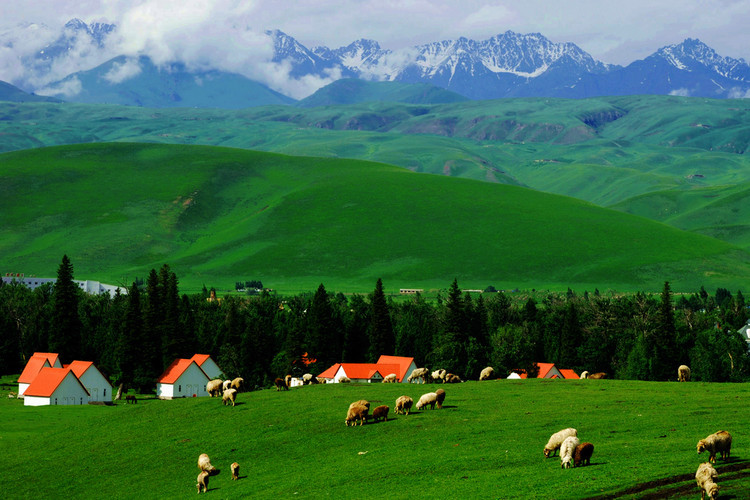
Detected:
left=0, top=143, right=750, bottom=291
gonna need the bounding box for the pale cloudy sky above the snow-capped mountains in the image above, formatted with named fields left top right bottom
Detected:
left=0, top=0, right=750, bottom=96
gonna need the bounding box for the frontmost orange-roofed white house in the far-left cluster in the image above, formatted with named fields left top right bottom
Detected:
left=23, top=366, right=89, bottom=406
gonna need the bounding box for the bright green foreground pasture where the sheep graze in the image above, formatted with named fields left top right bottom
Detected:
left=0, top=380, right=750, bottom=499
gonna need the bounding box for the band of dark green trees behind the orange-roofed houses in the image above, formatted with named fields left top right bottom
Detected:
left=0, top=256, right=750, bottom=392
